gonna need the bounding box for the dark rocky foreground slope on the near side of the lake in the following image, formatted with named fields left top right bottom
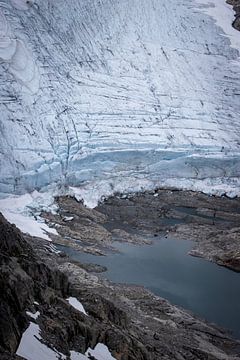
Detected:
left=0, top=212, right=240, bottom=360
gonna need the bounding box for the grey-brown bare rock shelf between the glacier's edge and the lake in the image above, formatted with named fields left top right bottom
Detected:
left=42, top=190, right=240, bottom=272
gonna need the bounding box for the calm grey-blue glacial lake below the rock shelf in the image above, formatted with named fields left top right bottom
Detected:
left=58, top=238, right=240, bottom=338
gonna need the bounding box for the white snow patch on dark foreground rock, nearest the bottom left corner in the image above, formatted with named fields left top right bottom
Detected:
left=16, top=322, right=66, bottom=360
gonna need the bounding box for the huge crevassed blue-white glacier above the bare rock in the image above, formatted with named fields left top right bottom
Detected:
left=0, top=0, right=240, bottom=200
